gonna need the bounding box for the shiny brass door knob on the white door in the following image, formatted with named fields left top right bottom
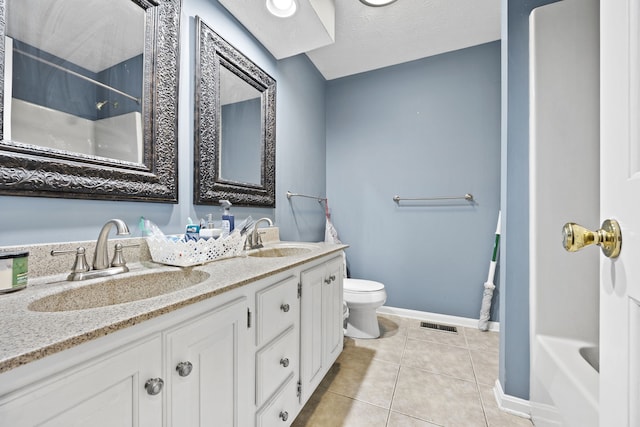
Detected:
left=562, top=219, right=622, bottom=258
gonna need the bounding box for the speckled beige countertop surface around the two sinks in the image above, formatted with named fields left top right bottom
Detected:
left=0, top=242, right=347, bottom=373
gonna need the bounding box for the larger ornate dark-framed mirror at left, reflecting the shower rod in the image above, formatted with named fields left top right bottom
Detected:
left=0, top=0, right=180, bottom=203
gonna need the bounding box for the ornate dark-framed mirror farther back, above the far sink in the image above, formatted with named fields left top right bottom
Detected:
left=194, top=17, right=276, bottom=207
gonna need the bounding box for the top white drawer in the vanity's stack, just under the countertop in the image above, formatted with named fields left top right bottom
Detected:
left=256, top=276, right=300, bottom=346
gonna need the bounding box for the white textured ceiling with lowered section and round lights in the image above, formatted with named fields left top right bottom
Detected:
left=219, top=0, right=500, bottom=80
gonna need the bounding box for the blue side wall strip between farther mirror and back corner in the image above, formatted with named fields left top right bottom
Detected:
left=276, top=55, right=328, bottom=242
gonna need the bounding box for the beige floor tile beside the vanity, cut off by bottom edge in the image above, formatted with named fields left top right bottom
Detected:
left=292, top=390, right=389, bottom=427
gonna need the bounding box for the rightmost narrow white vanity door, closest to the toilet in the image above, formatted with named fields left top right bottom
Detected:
left=322, top=258, right=344, bottom=366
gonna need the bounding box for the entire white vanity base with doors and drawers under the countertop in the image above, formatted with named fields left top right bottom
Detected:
left=0, top=249, right=343, bottom=427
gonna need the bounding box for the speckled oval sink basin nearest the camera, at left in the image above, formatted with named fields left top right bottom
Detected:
left=29, top=269, right=209, bottom=312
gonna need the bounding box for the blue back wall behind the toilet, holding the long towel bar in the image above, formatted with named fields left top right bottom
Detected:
left=327, top=42, right=500, bottom=320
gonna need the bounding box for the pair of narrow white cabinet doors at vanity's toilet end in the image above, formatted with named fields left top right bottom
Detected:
left=300, top=255, right=344, bottom=404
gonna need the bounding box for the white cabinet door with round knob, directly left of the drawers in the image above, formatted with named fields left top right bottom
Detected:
left=166, top=297, right=251, bottom=427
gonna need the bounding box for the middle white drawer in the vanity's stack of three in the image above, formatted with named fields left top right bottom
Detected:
left=256, top=326, right=299, bottom=407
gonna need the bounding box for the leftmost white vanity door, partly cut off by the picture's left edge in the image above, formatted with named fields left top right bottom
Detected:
left=0, top=334, right=162, bottom=427
